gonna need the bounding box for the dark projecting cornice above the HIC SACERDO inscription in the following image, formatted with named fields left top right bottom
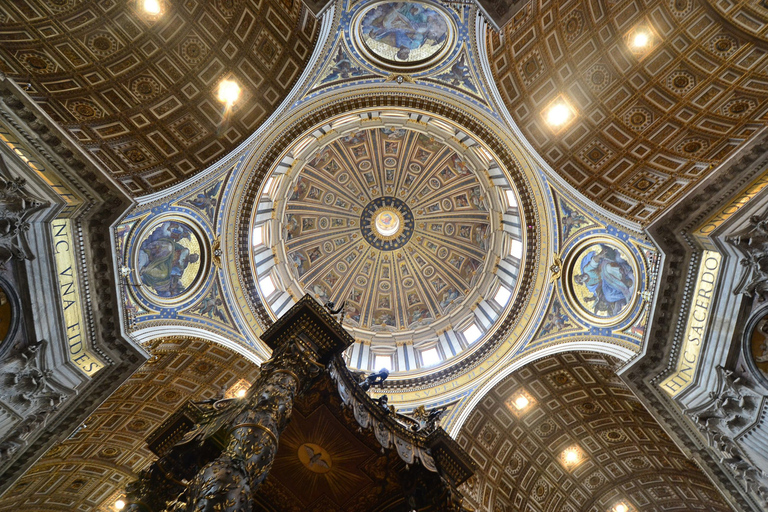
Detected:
left=621, top=128, right=768, bottom=510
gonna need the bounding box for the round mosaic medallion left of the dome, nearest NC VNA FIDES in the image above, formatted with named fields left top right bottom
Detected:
left=136, top=220, right=202, bottom=299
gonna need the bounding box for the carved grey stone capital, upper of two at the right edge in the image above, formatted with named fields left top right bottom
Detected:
left=725, top=211, right=768, bottom=302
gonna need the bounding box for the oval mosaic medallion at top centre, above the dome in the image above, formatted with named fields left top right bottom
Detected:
left=356, top=2, right=455, bottom=67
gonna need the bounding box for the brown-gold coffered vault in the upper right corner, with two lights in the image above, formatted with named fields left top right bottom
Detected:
left=488, top=0, right=768, bottom=224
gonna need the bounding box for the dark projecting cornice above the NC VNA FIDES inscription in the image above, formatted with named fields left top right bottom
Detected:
left=0, top=76, right=147, bottom=493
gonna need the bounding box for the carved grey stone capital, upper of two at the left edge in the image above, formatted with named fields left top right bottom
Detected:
left=0, top=155, right=49, bottom=268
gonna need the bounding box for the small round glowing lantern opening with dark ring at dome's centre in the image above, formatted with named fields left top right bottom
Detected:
left=360, top=197, right=414, bottom=251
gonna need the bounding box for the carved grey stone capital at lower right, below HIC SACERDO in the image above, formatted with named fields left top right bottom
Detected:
left=684, top=366, right=768, bottom=506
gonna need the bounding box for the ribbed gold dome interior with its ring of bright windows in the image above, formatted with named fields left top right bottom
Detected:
left=252, top=116, right=523, bottom=371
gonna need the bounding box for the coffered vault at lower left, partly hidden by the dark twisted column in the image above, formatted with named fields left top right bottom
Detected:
left=0, top=339, right=258, bottom=512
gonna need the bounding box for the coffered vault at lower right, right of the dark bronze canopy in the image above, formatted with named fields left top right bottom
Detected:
left=457, top=353, right=731, bottom=512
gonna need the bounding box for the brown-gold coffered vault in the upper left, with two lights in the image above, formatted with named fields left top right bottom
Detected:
left=0, top=0, right=319, bottom=194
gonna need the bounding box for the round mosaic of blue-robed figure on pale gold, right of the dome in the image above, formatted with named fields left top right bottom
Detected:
left=566, top=238, right=639, bottom=324
